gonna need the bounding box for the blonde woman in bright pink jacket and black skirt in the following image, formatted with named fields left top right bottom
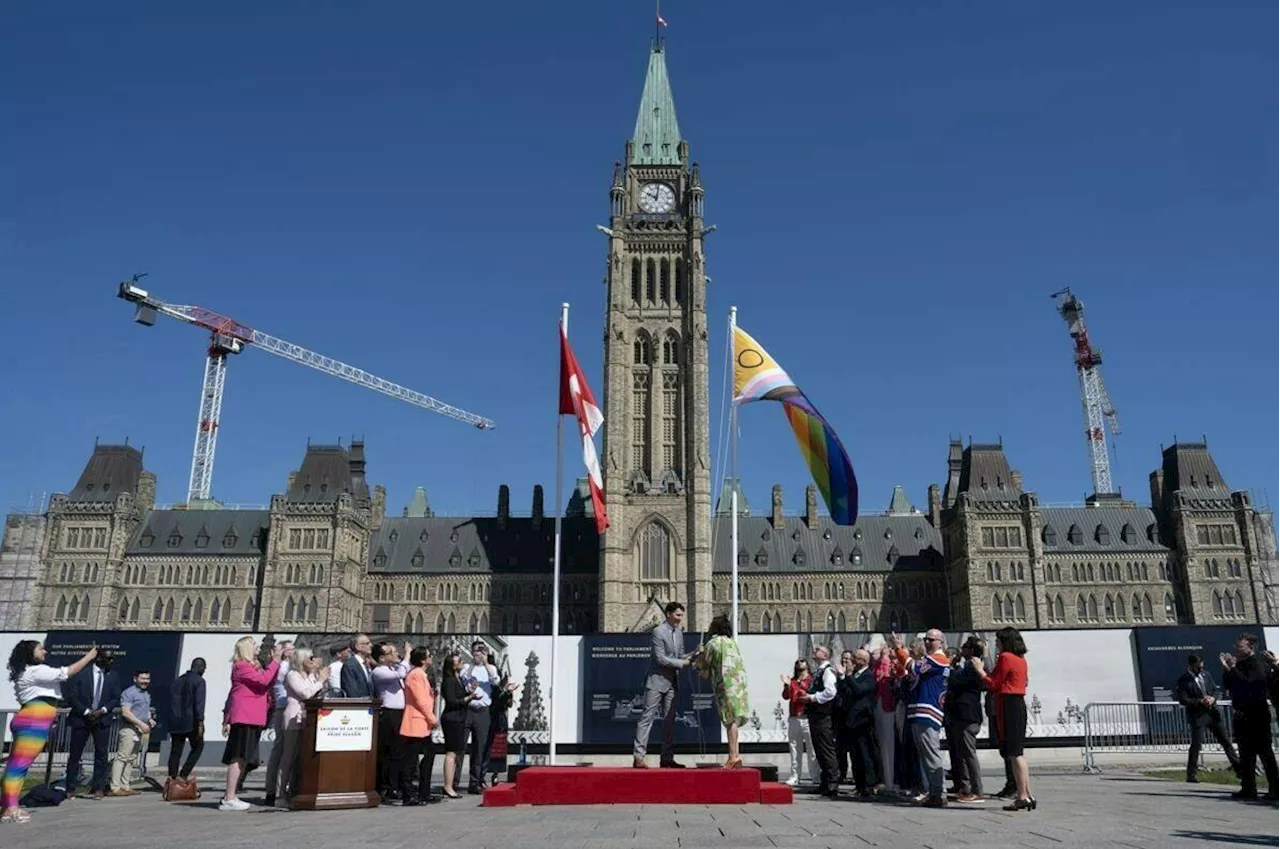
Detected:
left=218, top=636, right=280, bottom=811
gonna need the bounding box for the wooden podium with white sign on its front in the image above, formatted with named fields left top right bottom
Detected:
left=289, top=699, right=381, bottom=811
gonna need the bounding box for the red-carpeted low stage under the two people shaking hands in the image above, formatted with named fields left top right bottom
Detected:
left=484, top=767, right=791, bottom=808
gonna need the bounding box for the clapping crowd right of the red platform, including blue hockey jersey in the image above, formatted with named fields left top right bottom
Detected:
left=782, top=627, right=1037, bottom=811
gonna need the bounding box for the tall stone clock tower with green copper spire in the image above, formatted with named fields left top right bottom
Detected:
left=599, top=41, right=712, bottom=631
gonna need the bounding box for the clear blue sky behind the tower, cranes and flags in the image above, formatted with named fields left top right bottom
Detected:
left=0, top=0, right=1280, bottom=515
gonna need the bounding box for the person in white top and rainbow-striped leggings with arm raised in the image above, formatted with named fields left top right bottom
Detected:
left=0, top=640, right=97, bottom=822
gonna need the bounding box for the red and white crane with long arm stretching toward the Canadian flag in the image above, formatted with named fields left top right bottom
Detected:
left=118, top=274, right=494, bottom=503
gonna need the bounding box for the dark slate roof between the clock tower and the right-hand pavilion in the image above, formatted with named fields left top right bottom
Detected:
left=712, top=515, right=943, bottom=574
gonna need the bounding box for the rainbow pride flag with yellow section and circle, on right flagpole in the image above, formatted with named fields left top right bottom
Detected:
left=733, top=327, right=858, bottom=525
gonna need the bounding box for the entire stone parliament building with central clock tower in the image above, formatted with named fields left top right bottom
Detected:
left=0, top=44, right=1277, bottom=635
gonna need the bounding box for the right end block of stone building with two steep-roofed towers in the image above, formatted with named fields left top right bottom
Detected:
left=941, top=442, right=1276, bottom=629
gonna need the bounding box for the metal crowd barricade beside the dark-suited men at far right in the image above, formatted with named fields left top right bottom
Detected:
left=1084, top=702, right=1277, bottom=773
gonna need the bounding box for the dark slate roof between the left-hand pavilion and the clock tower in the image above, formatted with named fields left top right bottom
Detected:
left=369, top=516, right=600, bottom=575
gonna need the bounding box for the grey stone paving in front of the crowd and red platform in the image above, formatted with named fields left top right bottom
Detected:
left=12, top=772, right=1280, bottom=849
